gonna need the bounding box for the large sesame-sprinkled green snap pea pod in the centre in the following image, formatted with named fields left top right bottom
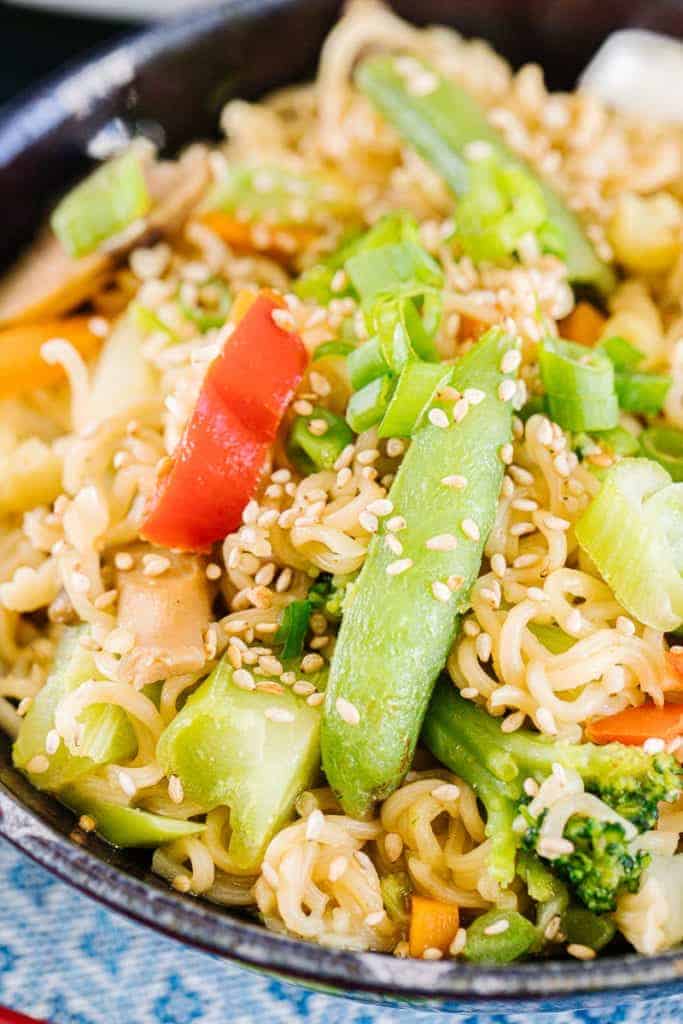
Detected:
left=323, top=329, right=513, bottom=816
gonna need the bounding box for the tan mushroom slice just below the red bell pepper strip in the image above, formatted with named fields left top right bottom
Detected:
left=117, top=547, right=211, bottom=688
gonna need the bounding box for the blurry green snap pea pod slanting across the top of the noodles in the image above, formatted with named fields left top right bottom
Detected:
left=355, top=56, right=614, bottom=293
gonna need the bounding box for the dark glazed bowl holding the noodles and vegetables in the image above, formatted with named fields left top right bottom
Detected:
left=0, top=0, right=683, bottom=1021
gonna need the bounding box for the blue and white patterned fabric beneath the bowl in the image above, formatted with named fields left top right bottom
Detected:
left=0, top=841, right=683, bottom=1024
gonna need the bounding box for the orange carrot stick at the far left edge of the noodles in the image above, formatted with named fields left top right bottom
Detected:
left=0, top=316, right=101, bottom=398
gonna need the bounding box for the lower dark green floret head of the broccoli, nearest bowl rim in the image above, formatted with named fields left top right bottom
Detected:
left=552, top=815, right=651, bottom=913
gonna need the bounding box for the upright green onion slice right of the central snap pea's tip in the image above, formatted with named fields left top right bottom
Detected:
left=539, top=338, right=618, bottom=432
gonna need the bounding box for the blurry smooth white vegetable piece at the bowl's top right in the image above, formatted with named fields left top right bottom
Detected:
left=579, top=29, right=683, bottom=122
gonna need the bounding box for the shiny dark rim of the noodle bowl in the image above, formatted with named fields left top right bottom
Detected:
left=0, top=0, right=683, bottom=1009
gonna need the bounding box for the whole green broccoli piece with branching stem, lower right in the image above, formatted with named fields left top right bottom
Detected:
left=422, top=678, right=683, bottom=908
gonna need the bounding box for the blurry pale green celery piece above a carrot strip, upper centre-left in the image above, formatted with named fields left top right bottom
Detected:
left=203, top=163, right=356, bottom=227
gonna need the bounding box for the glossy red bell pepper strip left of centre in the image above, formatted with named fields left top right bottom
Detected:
left=140, top=295, right=308, bottom=551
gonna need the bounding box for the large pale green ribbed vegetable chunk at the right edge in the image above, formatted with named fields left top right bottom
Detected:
left=575, top=459, right=683, bottom=631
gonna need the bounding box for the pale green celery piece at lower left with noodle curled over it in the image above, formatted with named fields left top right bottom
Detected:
left=12, top=627, right=137, bottom=792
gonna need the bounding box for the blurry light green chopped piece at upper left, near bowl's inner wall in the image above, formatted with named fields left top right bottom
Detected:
left=50, top=151, right=151, bottom=257
